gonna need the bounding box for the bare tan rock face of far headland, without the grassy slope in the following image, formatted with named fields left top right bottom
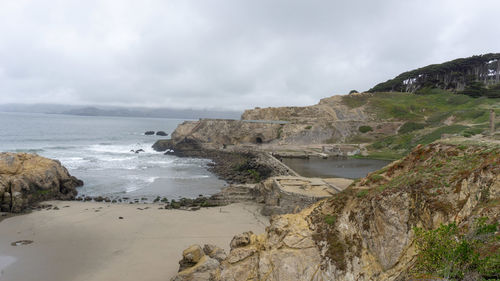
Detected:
left=161, top=96, right=403, bottom=148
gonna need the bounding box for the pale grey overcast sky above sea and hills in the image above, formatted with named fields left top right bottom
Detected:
left=0, top=0, right=500, bottom=109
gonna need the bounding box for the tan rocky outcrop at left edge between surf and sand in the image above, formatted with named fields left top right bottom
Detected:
left=0, top=153, right=83, bottom=213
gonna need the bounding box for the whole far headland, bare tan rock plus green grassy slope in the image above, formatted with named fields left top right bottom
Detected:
left=154, top=89, right=500, bottom=160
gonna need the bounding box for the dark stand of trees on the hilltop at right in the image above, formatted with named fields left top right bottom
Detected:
left=369, top=53, right=500, bottom=98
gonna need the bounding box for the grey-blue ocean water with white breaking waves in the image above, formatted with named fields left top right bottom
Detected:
left=0, top=112, right=225, bottom=200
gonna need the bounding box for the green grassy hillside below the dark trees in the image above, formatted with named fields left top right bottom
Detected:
left=343, top=89, right=500, bottom=159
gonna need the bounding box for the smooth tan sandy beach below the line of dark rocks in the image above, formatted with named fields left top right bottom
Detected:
left=0, top=201, right=269, bottom=281
